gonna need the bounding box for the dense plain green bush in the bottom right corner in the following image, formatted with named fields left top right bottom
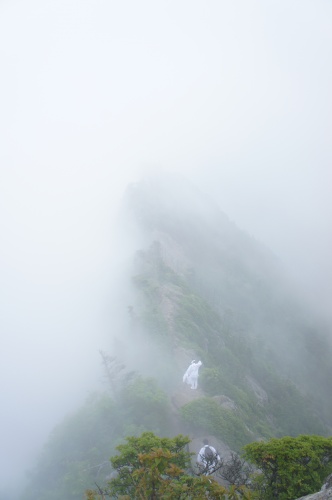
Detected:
left=244, top=435, right=332, bottom=500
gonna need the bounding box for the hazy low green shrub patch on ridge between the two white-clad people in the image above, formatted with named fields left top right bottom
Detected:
left=181, top=397, right=252, bottom=450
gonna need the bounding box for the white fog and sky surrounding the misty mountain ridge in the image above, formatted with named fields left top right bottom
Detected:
left=0, top=0, right=332, bottom=494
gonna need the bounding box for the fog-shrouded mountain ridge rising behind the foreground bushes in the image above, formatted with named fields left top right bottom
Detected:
left=24, top=176, right=332, bottom=500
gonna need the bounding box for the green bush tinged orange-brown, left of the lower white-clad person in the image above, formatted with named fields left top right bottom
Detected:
left=86, top=432, right=249, bottom=500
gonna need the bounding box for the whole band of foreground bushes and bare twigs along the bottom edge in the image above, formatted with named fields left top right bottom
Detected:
left=86, top=432, right=332, bottom=500
